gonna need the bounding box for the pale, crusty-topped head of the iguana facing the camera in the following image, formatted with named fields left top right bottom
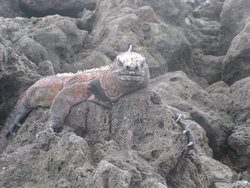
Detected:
left=111, top=50, right=149, bottom=86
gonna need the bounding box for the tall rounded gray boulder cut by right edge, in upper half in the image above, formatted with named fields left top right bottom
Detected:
left=222, top=19, right=250, bottom=84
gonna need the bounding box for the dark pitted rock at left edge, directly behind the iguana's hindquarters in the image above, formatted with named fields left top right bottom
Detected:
left=0, top=36, right=40, bottom=129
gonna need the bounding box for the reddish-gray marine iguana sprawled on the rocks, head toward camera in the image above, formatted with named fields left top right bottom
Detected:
left=3, top=50, right=150, bottom=138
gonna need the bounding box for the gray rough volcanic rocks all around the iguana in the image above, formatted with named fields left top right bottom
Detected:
left=0, top=0, right=250, bottom=188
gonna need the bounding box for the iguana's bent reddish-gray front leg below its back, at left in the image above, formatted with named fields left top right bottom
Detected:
left=47, top=82, right=91, bottom=130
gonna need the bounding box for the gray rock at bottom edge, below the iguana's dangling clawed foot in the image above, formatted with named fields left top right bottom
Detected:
left=167, top=154, right=237, bottom=188
